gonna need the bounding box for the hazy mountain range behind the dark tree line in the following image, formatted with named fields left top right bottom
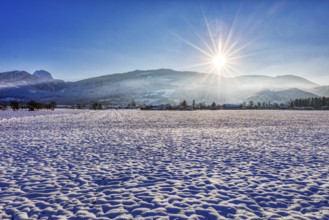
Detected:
left=0, top=69, right=329, bottom=105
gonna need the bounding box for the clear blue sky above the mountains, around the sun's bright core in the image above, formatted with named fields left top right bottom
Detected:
left=0, top=0, right=329, bottom=85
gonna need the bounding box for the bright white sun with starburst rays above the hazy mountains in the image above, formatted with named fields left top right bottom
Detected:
left=174, top=14, right=257, bottom=103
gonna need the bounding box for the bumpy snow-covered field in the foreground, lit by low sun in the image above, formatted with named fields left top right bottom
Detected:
left=0, top=110, right=329, bottom=219
